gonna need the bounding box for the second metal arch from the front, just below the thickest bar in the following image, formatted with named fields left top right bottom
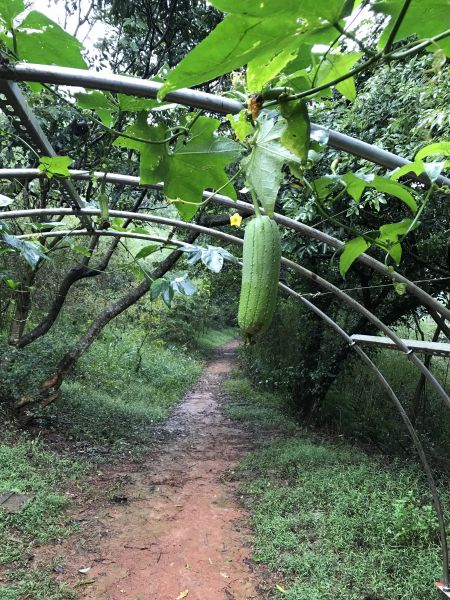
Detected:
left=0, top=169, right=450, bottom=320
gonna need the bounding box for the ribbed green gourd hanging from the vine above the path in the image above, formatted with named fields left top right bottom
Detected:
left=238, top=215, right=281, bottom=337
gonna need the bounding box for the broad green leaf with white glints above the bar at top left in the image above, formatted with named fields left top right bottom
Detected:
left=7, top=10, right=87, bottom=69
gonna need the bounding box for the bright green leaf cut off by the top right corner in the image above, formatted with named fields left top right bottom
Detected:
left=373, top=0, right=450, bottom=56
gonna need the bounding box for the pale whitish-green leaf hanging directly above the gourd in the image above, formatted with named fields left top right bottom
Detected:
left=241, top=112, right=300, bottom=216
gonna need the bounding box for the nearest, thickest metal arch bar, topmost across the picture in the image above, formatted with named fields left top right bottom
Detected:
left=0, top=63, right=450, bottom=187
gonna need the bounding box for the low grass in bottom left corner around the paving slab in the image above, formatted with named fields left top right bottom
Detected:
left=0, top=434, right=86, bottom=600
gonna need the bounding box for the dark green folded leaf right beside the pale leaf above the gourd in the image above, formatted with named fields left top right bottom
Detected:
left=280, top=101, right=311, bottom=162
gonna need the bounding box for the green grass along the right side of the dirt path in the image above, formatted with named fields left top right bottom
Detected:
left=226, top=380, right=450, bottom=600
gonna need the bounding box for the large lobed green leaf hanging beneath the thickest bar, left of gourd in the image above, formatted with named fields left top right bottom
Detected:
left=114, top=113, right=241, bottom=220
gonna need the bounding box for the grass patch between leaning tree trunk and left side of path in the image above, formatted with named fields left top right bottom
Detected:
left=47, top=332, right=201, bottom=455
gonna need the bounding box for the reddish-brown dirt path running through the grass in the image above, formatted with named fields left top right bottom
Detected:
left=56, top=343, right=261, bottom=600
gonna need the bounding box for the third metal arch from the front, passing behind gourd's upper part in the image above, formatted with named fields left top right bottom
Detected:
left=0, top=208, right=450, bottom=408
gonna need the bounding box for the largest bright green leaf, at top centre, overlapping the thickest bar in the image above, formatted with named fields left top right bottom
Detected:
left=160, top=0, right=356, bottom=97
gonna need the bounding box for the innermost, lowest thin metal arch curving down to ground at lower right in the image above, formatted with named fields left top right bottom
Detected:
left=17, top=223, right=449, bottom=586
